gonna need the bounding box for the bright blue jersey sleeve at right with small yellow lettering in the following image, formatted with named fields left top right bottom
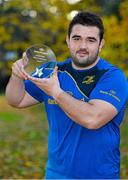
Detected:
left=89, top=69, right=128, bottom=111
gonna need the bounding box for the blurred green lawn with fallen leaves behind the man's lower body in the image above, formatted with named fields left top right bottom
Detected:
left=0, top=96, right=128, bottom=179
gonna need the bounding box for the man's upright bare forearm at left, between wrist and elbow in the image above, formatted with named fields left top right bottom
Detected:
left=6, top=75, right=25, bottom=107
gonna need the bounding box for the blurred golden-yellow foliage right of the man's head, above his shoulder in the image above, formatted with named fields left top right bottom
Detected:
left=101, top=10, right=128, bottom=75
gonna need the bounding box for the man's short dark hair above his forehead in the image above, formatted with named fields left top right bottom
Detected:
left=68, top=11, right=104, bottom=41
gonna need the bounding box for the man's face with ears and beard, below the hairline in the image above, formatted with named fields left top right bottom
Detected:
left=67, top=24, right=103, bottom=68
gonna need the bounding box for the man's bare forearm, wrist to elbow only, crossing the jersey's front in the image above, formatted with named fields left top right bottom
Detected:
left=54, top=91, right=93, bottom=128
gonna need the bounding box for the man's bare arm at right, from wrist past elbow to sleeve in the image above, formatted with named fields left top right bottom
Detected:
left=53, top=90, right=118, bottom=129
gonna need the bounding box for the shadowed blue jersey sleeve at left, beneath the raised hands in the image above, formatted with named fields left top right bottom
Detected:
left=24, top=80, right=45, bottom=102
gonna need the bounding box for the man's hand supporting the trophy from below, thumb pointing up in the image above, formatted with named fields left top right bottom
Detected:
left=27, top=67, right=63, bottom=99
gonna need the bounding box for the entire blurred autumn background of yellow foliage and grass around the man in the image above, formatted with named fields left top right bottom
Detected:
left=0, top=0, right=128, bottom=179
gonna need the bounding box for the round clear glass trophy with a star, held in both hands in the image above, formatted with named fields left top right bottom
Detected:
left=25, top=44, right=57, bottom=78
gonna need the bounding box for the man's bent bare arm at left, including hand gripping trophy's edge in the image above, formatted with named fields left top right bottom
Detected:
left=6, top=53, right=38, bottom=108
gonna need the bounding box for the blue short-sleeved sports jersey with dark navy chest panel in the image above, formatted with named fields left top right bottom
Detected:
left=25, top=58, right=128, bottom=179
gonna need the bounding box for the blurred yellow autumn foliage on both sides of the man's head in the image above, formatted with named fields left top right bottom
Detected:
left=0, top=0, right=128, bottom=75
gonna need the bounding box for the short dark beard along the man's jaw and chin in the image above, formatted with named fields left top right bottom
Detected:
left=71, top=50, right=99, bottom=68
